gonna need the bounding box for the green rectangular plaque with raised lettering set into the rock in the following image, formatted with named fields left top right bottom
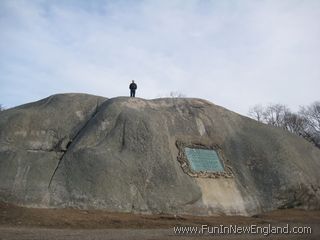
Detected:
left=184, top=147, right=224, bottom=172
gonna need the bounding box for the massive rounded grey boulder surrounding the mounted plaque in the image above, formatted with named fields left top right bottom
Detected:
left=0, top=94, right=320, bottom=215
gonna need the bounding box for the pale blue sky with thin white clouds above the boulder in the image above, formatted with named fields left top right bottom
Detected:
left=0, top=0, right=320, bottom=114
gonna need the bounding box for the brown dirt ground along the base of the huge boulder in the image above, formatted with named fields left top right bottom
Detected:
left=0, top=203, right=320, bottom=240
